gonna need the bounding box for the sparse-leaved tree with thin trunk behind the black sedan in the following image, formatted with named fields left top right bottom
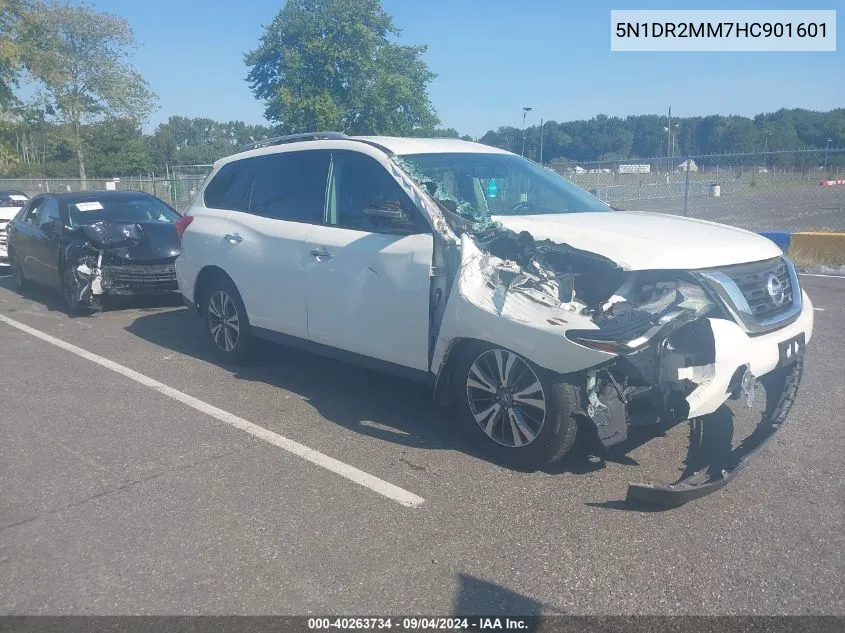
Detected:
left=23, top=3, right=155, bottom=188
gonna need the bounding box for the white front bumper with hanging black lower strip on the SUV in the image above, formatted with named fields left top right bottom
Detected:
left=627, top=294, right=813, bottom=507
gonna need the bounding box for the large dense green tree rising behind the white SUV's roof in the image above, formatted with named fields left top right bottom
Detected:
left=245, top=0, right=439, bottom=135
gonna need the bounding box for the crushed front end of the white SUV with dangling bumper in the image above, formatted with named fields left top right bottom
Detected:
left=435, top=228, right=813, bottom=506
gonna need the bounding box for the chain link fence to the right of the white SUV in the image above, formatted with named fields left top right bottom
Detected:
left=549, top=148, right=845, bottom=232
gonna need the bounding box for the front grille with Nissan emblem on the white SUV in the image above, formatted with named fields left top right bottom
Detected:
left=722, top=257, right=793, bottom=322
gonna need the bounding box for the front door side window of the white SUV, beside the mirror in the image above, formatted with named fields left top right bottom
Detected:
left=325, top=152, right=429, bottom=233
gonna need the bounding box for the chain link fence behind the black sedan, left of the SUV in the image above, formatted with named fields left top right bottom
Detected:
left=0, top=165, right=212, bottom=211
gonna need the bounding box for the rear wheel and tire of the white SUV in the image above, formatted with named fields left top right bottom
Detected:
left=201, top=275, right=254, bottom=365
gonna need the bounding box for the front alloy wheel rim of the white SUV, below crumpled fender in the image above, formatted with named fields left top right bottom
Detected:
left=466, top=349, right=547, bottom=448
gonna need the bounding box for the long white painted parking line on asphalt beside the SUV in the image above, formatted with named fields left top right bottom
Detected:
left=0, top=314, right=425, bottom=508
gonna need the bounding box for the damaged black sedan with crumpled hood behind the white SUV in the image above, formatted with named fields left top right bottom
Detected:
left=8, top=191, right=180, bottom=313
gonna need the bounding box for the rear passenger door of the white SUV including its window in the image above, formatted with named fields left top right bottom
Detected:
left=221, top=150, right=331, bottom=339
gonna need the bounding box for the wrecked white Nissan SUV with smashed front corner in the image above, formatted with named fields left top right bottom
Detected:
left=176, top=133, right=813, bottom=503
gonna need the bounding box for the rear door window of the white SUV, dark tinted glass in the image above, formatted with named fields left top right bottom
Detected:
left=249, top=150, right=331, bottom=223
